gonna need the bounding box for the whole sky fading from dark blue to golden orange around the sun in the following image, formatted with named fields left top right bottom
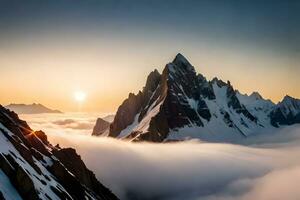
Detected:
left=0, top=0, right=300, bottom=112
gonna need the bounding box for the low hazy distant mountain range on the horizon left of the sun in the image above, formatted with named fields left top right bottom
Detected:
left=5, top=103, right=62, bottom=114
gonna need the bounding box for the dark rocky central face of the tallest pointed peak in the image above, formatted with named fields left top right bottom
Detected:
left=135, top=54, right=210, bottom=142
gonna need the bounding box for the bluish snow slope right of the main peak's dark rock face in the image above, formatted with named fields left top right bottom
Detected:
left=165, top=82, right=274, bottom=142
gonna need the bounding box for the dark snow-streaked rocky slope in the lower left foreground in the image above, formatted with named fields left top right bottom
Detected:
left=0, top=106, right=117, bottom=200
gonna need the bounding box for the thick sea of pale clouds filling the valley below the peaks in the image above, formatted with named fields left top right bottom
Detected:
left=22, top=114, right=300, bottom=200
